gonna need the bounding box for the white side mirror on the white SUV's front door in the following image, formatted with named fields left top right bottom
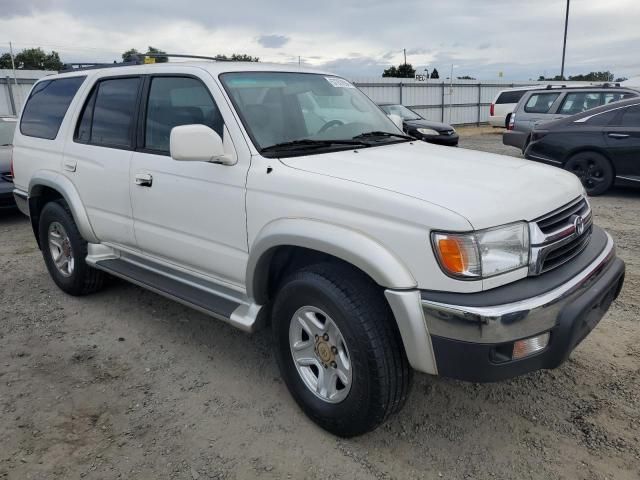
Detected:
left=169, top=125, right=235, bottom=165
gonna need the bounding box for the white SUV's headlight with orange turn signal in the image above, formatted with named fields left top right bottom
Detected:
left=431, top=222, right=529, bottom=279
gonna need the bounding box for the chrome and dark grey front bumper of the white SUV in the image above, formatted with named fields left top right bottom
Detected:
left=422, top=227, right=625, bottom=382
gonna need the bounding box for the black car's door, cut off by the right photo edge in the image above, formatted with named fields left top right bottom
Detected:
left=606, top=104, right=640, bottom=181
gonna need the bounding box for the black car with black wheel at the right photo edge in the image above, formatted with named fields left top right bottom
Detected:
left=525, top=98, right=640, bottom=195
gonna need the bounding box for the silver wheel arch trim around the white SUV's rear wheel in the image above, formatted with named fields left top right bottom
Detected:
left=29, top=170, right=98, bottom=246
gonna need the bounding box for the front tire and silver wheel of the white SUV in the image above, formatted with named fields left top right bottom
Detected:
left=272, top=263, right=413, bottom=437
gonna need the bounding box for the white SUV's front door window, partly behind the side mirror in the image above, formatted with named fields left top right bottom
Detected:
left=144, top=77, right=224, bottom=153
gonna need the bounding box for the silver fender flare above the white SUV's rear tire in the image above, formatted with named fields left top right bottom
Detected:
left=29, top=170, right=99, bottom=243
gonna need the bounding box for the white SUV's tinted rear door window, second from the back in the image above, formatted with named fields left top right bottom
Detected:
left=75, top=77, right=140, bottom=148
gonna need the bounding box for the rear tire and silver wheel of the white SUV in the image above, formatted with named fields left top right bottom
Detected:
left=38, top=201, right=105, bottom=295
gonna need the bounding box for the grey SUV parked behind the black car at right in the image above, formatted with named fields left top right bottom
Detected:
left=502, top=84, right=640, bottom=153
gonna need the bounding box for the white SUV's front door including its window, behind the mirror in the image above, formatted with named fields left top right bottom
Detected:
left=129, top=75, right=250, bottom=285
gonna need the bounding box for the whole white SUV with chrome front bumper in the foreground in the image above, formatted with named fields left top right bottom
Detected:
left=13, top=61, right=624, bottom=436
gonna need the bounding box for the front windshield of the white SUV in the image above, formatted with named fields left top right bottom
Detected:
left=220, top=72, right=406, bottom=153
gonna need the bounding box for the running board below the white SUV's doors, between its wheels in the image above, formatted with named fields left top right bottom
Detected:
left=87, top=257, right=260, bottom=333
